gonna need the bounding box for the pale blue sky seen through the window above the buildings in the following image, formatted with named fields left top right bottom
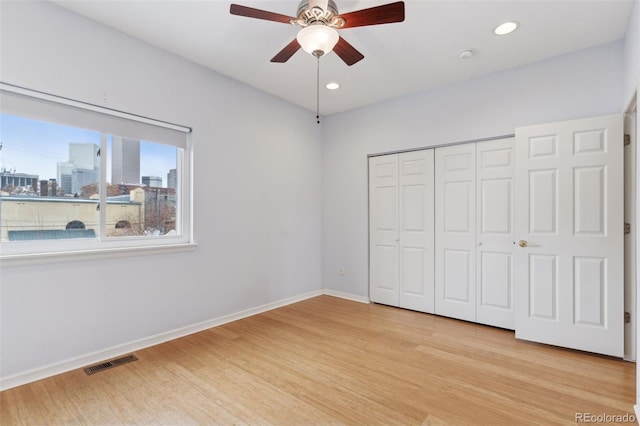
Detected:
left=0, top=113, right=176, bottom=186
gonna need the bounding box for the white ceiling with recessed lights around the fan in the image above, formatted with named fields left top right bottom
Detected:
left=52, top=0, right=633, bottom=115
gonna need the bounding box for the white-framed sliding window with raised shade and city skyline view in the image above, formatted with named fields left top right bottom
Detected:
left=0, top=83, right=192, bottom=258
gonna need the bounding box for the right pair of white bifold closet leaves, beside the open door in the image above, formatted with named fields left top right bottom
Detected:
left=435, top=138, right=515, bottom=329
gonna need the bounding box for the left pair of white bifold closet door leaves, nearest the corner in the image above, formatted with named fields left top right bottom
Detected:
left=369, top=149, right=434, bottom=313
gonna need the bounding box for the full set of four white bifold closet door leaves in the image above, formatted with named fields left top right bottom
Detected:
left=369, top=138, right=514, bottom=329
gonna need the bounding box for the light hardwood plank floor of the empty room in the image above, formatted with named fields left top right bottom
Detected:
left=0, top=296, right=635, bottom=426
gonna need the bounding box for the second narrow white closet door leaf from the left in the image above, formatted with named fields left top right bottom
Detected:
left=398, top=149, right=434, bottom=313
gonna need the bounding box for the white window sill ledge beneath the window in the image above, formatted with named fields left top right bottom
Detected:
left=0, top=243, right=198, bottom=268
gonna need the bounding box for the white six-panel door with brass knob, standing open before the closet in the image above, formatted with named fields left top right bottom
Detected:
left=515, top=114, right=624, bottom=357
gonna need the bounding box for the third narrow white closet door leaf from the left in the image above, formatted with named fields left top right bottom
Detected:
left=435, top=144, right=476, bottom=321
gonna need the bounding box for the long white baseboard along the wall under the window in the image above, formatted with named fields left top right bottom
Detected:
left=0, top=290, right=322, bottom=391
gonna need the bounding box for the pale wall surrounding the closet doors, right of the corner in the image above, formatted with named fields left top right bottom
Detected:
left=323, top=42, right=623, bottom=296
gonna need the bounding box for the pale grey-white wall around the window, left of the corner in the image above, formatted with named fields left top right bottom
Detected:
left=0, top=1, right=322, bottom=378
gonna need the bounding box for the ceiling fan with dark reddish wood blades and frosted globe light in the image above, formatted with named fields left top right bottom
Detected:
left=230, top=0, right=404, bottom=66
